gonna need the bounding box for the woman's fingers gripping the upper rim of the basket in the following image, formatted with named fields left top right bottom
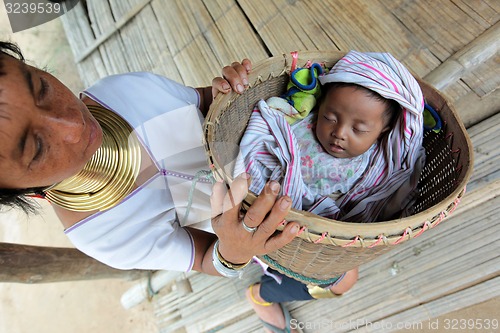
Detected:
left=212, top=59, right=252, bottom=98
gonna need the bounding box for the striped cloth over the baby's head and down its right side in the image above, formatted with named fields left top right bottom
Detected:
left=319, top=51, right=425, bottom=222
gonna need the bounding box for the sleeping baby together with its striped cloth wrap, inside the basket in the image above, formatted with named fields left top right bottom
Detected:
left=237, top=51, right=425, bottom=222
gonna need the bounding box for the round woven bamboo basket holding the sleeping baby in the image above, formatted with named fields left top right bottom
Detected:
left=204, top=51, right=473, bottom=284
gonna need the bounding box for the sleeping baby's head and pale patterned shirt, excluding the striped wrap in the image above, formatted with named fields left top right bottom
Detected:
left=291, top=82, right=401, bottom=198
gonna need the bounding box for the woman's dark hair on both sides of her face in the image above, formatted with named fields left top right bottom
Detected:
left=0, top=41, right=43, bottom=213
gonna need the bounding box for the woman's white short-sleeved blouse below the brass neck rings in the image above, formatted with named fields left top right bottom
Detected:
left=65, top=72, right=211, bottom=271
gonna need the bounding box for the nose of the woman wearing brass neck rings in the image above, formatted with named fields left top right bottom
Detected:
left=44, top=110, right=85, bottom=143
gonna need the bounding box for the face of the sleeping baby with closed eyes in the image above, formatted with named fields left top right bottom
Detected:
left=316, top=87, right=389, bottom=158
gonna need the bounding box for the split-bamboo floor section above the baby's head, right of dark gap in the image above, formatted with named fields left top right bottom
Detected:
left=241, top=1, right=440, bottom=76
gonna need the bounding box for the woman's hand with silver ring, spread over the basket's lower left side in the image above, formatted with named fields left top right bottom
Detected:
left=211, top=174, right=299, bottom=264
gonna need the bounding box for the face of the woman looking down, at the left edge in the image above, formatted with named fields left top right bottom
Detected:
left=0, top=55, right=102, bottom=189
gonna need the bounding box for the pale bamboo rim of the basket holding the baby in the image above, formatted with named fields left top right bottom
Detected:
left=204, top=50, right=473, bottom=247
